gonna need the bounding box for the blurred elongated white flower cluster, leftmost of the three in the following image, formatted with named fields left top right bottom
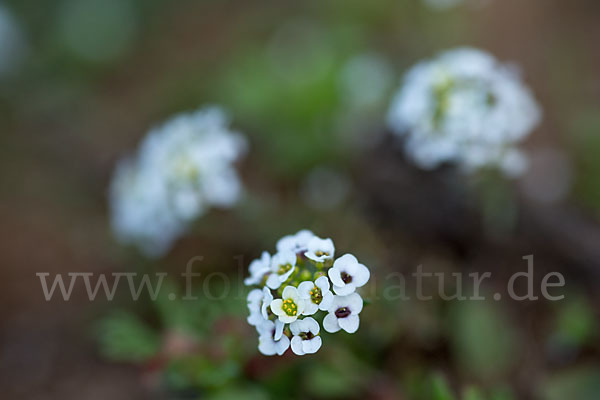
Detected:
left=110, top=107, right=246, bottom=257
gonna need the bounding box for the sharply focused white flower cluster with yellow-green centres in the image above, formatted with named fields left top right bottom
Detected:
left=244, top=230, right=370, bottom=356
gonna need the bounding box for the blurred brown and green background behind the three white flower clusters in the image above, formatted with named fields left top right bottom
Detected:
left=0, top=0, right=600, bottom=400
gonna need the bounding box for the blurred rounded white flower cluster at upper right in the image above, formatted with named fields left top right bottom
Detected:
left=387, top=48, right=541, bottom=176
